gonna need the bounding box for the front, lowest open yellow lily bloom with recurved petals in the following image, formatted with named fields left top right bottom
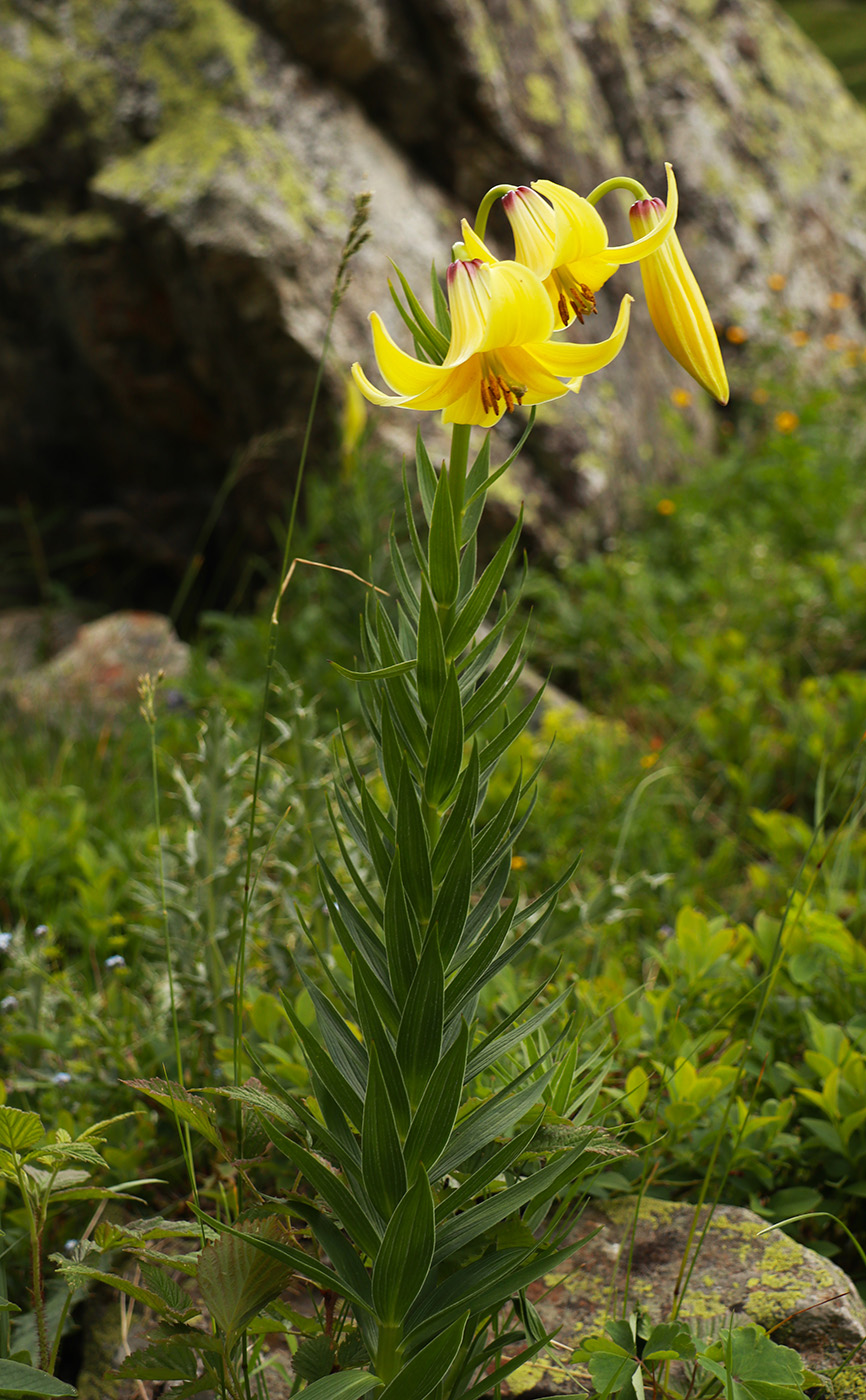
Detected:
left=351, top=249, right=631, bottom=427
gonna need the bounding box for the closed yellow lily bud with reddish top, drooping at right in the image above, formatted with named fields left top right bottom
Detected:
left=628, top=191, right=729, bottom=403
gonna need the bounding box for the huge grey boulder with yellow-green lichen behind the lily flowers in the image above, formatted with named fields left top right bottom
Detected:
left=0, top=0, right=866, bottom=596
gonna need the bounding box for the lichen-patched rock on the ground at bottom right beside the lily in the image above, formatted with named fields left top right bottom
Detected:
left=509, top=1200, right=866, bottom=1396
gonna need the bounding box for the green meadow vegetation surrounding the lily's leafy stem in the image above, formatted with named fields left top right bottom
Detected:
left=0, top=306, right=866, bottom=1396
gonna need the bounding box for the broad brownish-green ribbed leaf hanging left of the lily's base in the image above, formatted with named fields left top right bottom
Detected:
left=197, top=1215, right=294, bottom=1348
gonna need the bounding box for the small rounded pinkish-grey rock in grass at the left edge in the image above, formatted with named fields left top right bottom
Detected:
left=8, top=612, right=189, bottom=729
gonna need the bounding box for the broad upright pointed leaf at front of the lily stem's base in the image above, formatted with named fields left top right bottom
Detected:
left=372, top=1172, right=435, bottom=1326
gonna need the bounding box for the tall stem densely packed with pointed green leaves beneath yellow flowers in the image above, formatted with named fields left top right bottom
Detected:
left=187, top=397, right=629, bottom=1400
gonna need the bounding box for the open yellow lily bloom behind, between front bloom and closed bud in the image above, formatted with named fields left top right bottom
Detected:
left=463, top=165, right=677, bottom=326
